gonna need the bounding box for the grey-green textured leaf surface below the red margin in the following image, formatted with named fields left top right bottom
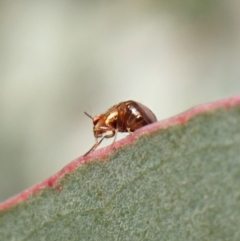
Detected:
left=0, top=98, right=240, bottom=241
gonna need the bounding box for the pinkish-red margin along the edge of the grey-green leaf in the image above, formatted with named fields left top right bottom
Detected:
left=0, top=95, right=240, bottom=211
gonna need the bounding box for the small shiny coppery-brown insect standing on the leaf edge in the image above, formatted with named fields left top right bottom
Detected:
left=84, top=100, right=157, bottom=156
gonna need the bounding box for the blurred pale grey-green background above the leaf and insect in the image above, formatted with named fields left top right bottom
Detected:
left=0, top=0, right=240, bottom=201
